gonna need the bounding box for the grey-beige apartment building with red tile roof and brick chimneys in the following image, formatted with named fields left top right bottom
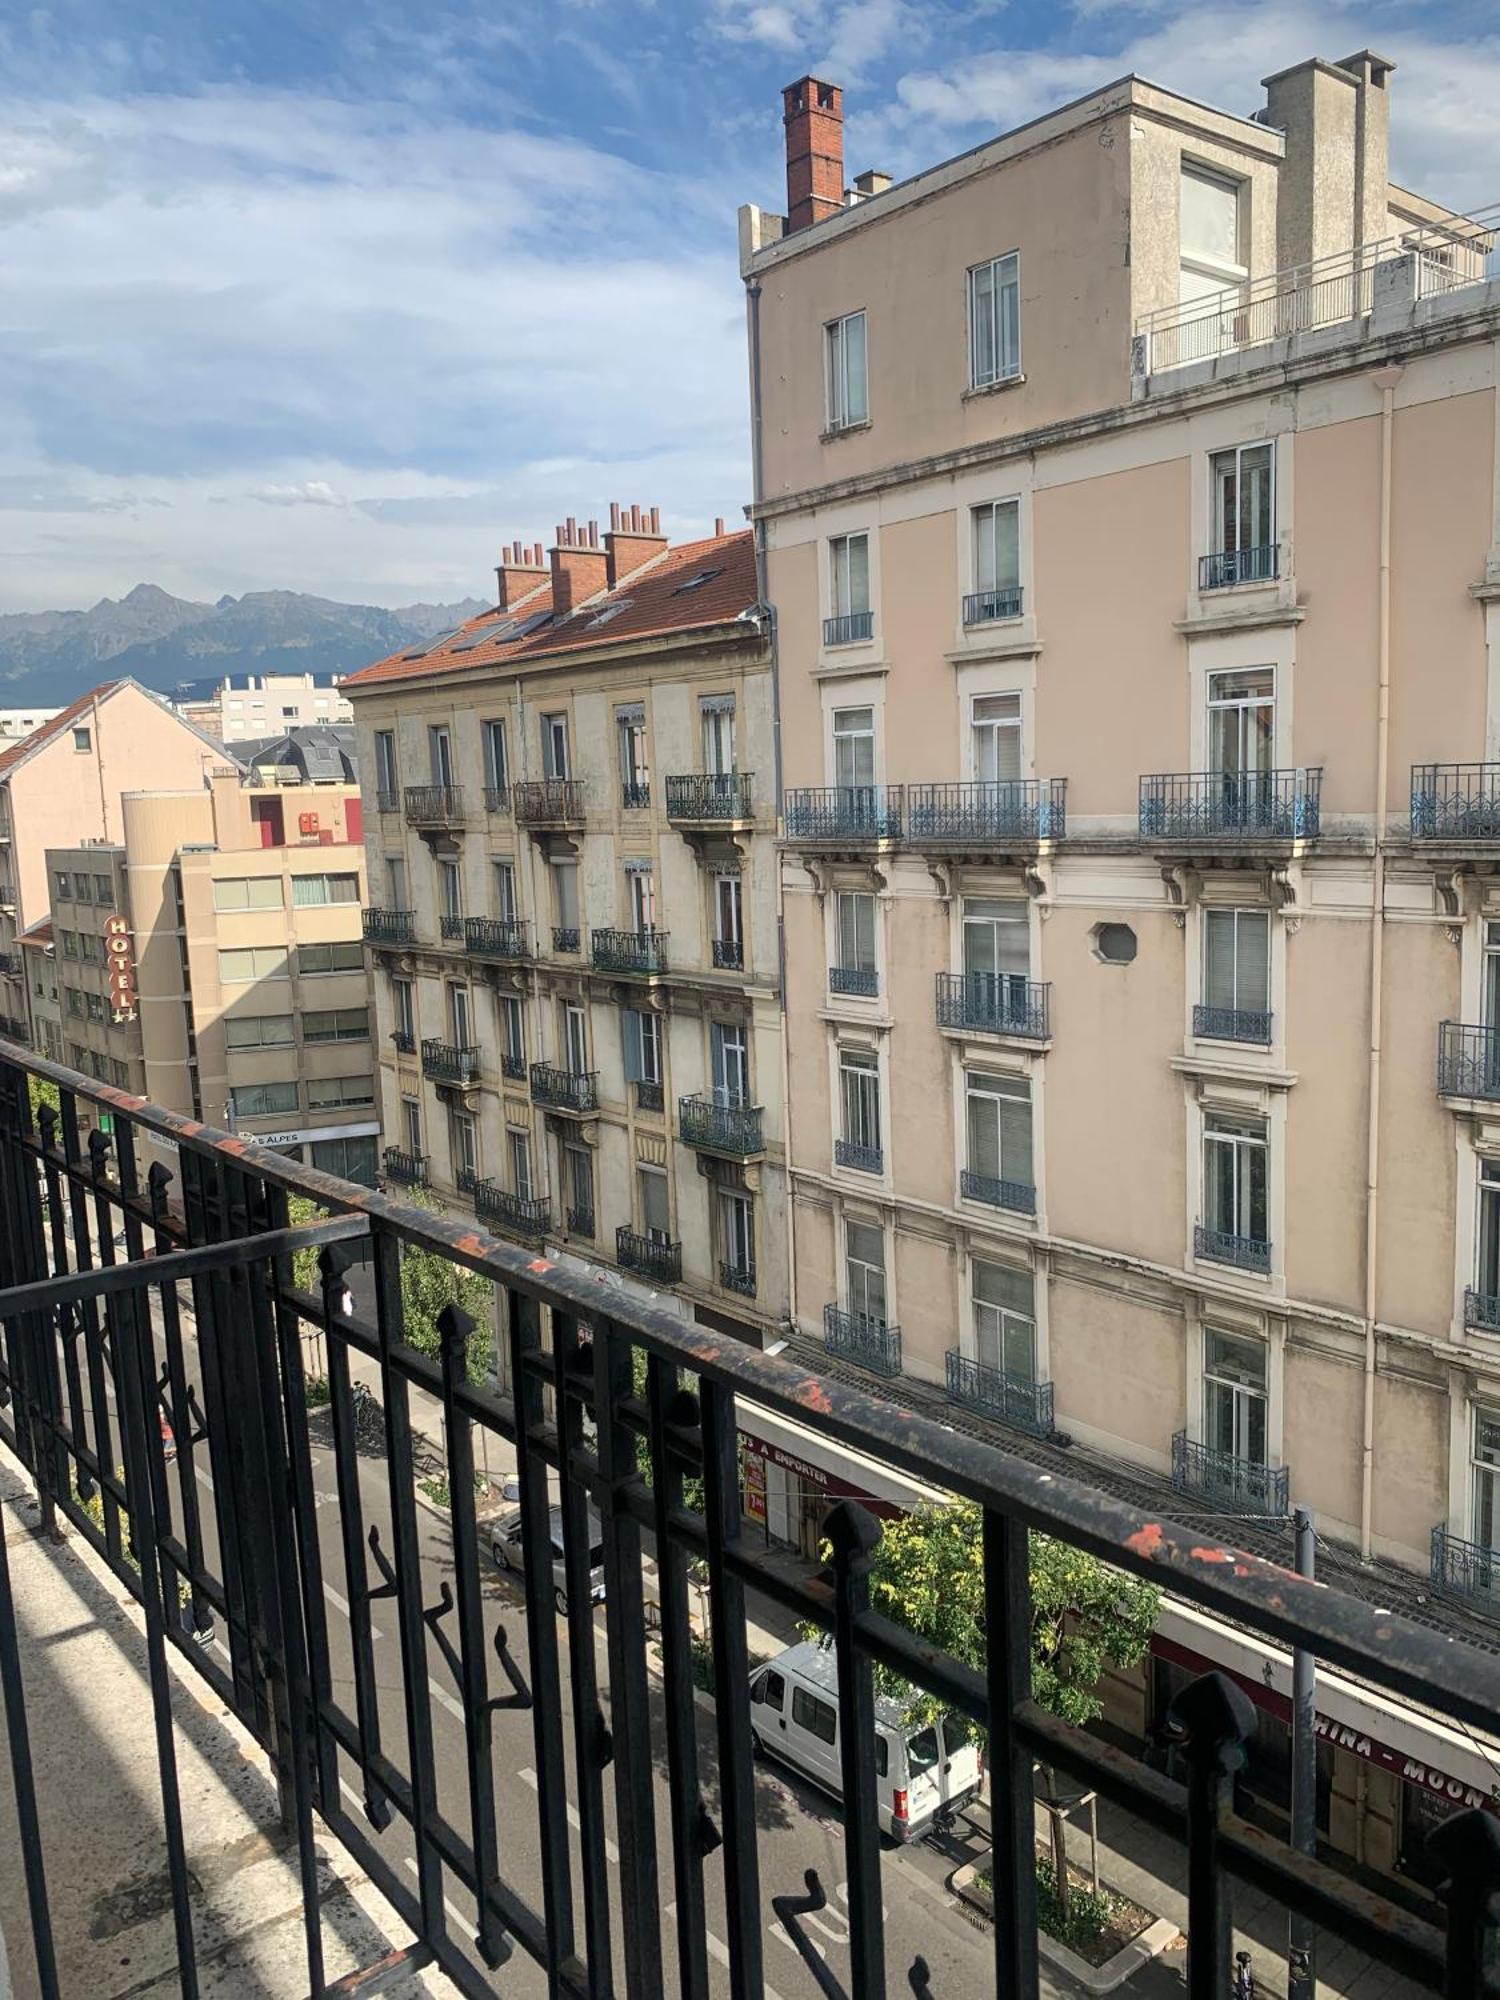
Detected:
left=344, top=506, right=786, bottom=1342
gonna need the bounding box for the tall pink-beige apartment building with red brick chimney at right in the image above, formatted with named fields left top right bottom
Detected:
left=740, top=50, right=1500, bottom=1870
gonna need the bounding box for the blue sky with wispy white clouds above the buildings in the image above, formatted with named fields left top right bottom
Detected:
left=0, top=0, right=1500, bottom=612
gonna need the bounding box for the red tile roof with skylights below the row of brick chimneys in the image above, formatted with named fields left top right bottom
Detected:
left=340, top=528, right=758, bottom=690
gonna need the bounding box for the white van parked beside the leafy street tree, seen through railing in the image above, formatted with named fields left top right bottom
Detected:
left=750, top=1640, right=980, bottom=1840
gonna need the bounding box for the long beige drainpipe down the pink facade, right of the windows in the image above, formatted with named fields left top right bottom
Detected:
left=1360, top=368, right=1402, bottom=1562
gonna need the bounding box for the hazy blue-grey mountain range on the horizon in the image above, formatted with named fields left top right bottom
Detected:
left=0, top=584, right=484, bottom=708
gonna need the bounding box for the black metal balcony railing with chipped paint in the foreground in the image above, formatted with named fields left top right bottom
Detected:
left=0, top=1052, right=1500, bottom=2000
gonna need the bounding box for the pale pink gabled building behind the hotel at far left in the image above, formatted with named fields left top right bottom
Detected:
left=0, top=680, right=224, bottom=1042
